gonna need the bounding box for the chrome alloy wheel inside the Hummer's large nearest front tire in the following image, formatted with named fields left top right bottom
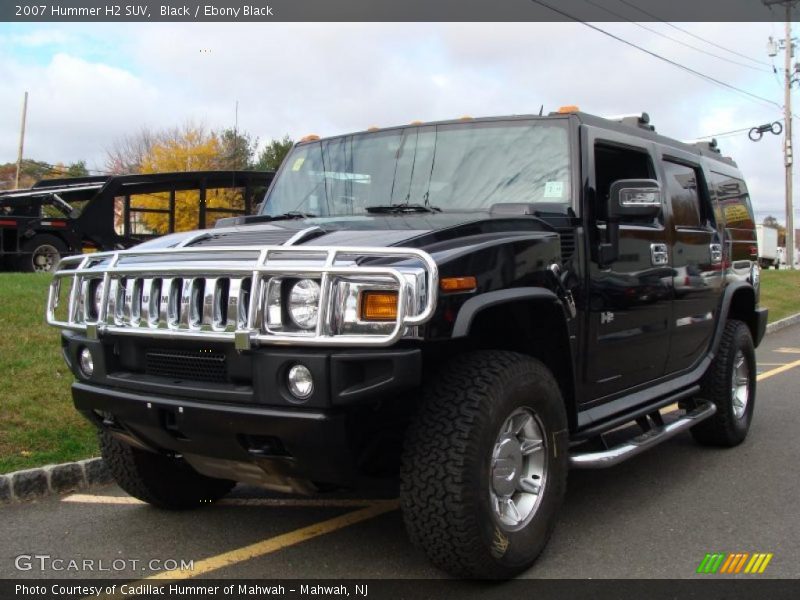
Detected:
left=489, top=408, right=547, bottom=531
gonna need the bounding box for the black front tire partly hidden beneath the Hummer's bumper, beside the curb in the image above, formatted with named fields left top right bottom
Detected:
left=99, top=431, right=235, bottom=510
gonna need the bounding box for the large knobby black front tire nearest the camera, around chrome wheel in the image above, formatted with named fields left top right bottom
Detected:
left=400, top=351, right=568, bottom=579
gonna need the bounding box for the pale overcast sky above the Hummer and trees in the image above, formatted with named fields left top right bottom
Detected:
left=0, top=23, right=800, bottom=222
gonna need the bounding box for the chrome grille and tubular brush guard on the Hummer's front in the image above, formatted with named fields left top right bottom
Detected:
left=46, top=246, right=439, bottom=350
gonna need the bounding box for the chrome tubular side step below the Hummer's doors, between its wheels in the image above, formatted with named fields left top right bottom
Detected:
left=569, top=402, right=717, bottom=469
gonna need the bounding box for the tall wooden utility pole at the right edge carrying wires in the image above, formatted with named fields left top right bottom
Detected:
left=763, top=0, right=797, bottom=269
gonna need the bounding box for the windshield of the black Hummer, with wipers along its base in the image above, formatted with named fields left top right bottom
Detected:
left=261, top=120, right=570, bottom=216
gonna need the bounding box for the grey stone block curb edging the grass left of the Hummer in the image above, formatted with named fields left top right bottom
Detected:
left=0, top=458, right=112, bottom=504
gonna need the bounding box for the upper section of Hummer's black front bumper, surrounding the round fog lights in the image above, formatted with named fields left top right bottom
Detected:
left=62, top=332, right=422, bottom=409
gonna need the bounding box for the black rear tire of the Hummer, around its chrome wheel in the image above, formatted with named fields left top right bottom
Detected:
left=691, top=319, right=756, bottom=447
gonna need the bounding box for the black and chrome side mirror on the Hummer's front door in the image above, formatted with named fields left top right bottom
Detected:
left=597, top=179, right=661, bottom=267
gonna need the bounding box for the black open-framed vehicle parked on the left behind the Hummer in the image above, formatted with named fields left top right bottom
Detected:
left=0, top=171, right=274, bottom=272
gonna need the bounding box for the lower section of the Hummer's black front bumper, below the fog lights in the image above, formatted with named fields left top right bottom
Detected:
left=72, top=382, right=355, bottom=491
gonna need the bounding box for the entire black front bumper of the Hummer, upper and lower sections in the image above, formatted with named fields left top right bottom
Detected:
left=62, top=332, right=422, bottom=492
